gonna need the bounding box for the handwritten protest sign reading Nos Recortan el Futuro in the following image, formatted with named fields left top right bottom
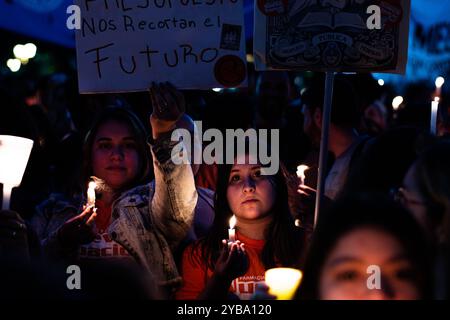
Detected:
left=75, top=0, right=246, bottom=93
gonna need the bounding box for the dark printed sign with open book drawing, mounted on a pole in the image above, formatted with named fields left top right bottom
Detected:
left=254, top=0, right=410, bottom=73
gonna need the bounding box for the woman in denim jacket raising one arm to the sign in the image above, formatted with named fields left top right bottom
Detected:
left=27, top=83, right=202, bottom=298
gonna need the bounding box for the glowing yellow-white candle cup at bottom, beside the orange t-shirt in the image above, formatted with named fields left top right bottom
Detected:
left=264, top=268, right=303, bottom=300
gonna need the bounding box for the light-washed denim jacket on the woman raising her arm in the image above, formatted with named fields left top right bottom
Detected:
left=32, top=135, right=212, bottom=293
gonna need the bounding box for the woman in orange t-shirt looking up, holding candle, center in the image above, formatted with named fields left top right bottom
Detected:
left=177, top=145, right=304, bottom=299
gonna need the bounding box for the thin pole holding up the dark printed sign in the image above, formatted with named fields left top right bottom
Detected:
left=314, top=71, right=334, bottom=228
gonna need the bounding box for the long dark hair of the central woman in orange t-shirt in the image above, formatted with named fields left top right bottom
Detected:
left=191, top=151, right=304, bottom=270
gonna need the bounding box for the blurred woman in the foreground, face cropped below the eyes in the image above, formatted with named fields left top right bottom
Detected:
left=297, top=193, right=432, bottom=300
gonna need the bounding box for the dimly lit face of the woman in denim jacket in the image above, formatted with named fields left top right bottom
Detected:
left=92, top=121, right=139, bottom=190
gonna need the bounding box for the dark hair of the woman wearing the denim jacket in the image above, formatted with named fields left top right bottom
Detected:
left=80, top=106, right=151, bottom=192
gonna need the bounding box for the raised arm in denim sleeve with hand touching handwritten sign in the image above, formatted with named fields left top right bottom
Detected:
left=150, top=83, right=198, bottom=248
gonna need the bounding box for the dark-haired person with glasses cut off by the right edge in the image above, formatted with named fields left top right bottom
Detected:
left=396, top=141, right=450, bottom=299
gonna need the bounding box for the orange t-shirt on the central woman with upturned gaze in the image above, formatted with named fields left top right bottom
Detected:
left=176, top=232, right=265, bottom=300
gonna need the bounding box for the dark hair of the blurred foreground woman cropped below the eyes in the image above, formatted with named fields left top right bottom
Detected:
left=296, top=193, right=433, bottom=300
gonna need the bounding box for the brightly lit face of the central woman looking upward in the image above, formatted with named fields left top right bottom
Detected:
left=227, top=155, right=276, bottom=220
